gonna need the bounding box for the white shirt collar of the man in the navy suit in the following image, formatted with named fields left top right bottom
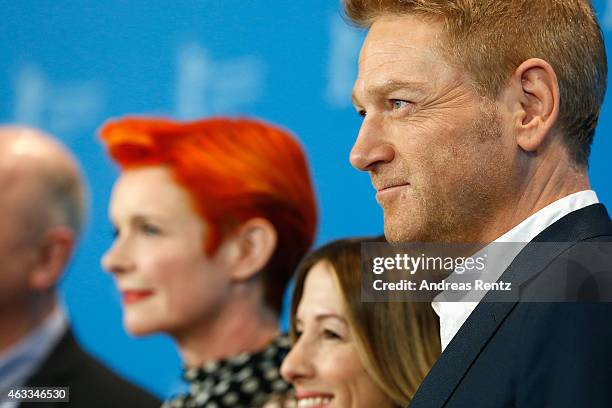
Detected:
left=432, top=190, right=599, bottom=350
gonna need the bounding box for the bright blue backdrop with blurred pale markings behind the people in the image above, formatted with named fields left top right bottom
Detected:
left=0, top=0, right=612, bottom=397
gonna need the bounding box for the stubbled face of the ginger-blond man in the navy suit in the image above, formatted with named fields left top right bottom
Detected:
left=351, top=16, right=515, bottom=242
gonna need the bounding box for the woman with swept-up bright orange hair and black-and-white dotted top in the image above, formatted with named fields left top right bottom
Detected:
left=101, top=118, right=317, bottom=407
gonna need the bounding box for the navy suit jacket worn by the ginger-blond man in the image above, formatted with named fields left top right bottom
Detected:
left=410, top=204, right=612, bottom=408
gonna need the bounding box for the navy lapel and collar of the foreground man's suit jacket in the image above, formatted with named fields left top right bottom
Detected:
left=410, top=204, right=612, bottom=408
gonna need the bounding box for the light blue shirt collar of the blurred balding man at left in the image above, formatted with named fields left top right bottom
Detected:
left=0, top=306, right=68, bottom=408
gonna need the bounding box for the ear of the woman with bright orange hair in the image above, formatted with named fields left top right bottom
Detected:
left=230, top=218, right=278, bottom=282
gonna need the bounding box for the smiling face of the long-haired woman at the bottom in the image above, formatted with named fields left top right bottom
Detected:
left=281, top=261, right=393, bottom=408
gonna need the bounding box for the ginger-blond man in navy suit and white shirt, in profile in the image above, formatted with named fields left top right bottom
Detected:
left=344, top=0, right=612, bottom=408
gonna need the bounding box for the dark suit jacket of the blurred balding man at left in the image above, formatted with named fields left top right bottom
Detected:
left=19, top=331, right=161, bottom=408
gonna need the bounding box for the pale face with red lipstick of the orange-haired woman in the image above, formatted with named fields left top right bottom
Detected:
left=102, top=166, right=230, bottom=336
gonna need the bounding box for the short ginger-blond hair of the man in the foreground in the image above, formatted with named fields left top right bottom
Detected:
left=344, top=0, right=608, bottom=167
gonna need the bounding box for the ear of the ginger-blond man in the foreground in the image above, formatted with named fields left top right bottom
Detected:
left=507, top=58, right=559, bottom=152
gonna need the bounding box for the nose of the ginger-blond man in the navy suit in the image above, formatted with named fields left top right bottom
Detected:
left=350, top=116, right=395, bottom=171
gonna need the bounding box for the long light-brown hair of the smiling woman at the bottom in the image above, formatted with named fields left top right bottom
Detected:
left=290, top=238, right=440, bottom=407
